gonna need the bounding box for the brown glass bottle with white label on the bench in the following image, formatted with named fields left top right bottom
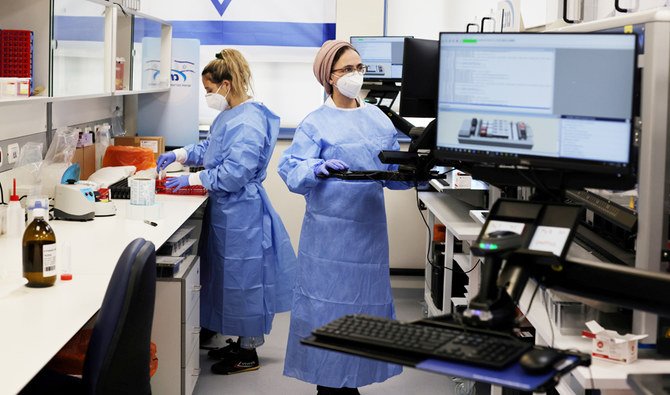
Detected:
left=23, top=207, right=56, bottom=288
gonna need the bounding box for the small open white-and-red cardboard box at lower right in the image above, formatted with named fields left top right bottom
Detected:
left=582, top=321, right=647, bottom=364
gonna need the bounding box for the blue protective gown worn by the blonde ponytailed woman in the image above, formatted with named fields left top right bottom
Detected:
left=184, top=101, right=296, bottom=336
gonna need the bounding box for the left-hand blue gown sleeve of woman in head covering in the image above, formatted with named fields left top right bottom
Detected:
left=279, top=125, right=324, bottom=195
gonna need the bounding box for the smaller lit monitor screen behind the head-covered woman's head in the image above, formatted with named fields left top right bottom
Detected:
left=351, top=36, right=405, bottom=81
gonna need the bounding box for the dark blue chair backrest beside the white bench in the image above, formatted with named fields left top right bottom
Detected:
left=82, top=238, right=156, bottom=394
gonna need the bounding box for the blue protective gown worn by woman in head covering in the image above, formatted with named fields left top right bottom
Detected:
left=279, top=101, right=409, bottom=387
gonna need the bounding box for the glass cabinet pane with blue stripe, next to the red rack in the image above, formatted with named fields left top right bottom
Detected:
left=51, top=0, right=108, bottom=96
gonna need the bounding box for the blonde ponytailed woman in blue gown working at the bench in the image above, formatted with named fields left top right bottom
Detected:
left=157, top=49, right=296, bottom=374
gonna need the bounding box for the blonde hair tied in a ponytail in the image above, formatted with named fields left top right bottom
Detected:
left=202, top=48, right=252, bottom=96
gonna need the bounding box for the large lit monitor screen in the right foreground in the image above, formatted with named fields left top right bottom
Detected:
left=437, top=33, right=636, bottom=174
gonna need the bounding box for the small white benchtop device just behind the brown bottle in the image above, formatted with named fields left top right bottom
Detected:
left=54, top=183, right=95, bottom=221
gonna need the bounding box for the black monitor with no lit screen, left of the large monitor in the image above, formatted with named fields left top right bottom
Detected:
left=400, top=38, right=440, bottom=118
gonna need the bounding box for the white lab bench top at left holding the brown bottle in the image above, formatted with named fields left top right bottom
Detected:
left=0, top=195, right=207, bottom=394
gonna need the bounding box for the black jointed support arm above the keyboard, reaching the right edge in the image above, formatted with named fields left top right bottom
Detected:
left=463, top=249, right=670, bottom=330
